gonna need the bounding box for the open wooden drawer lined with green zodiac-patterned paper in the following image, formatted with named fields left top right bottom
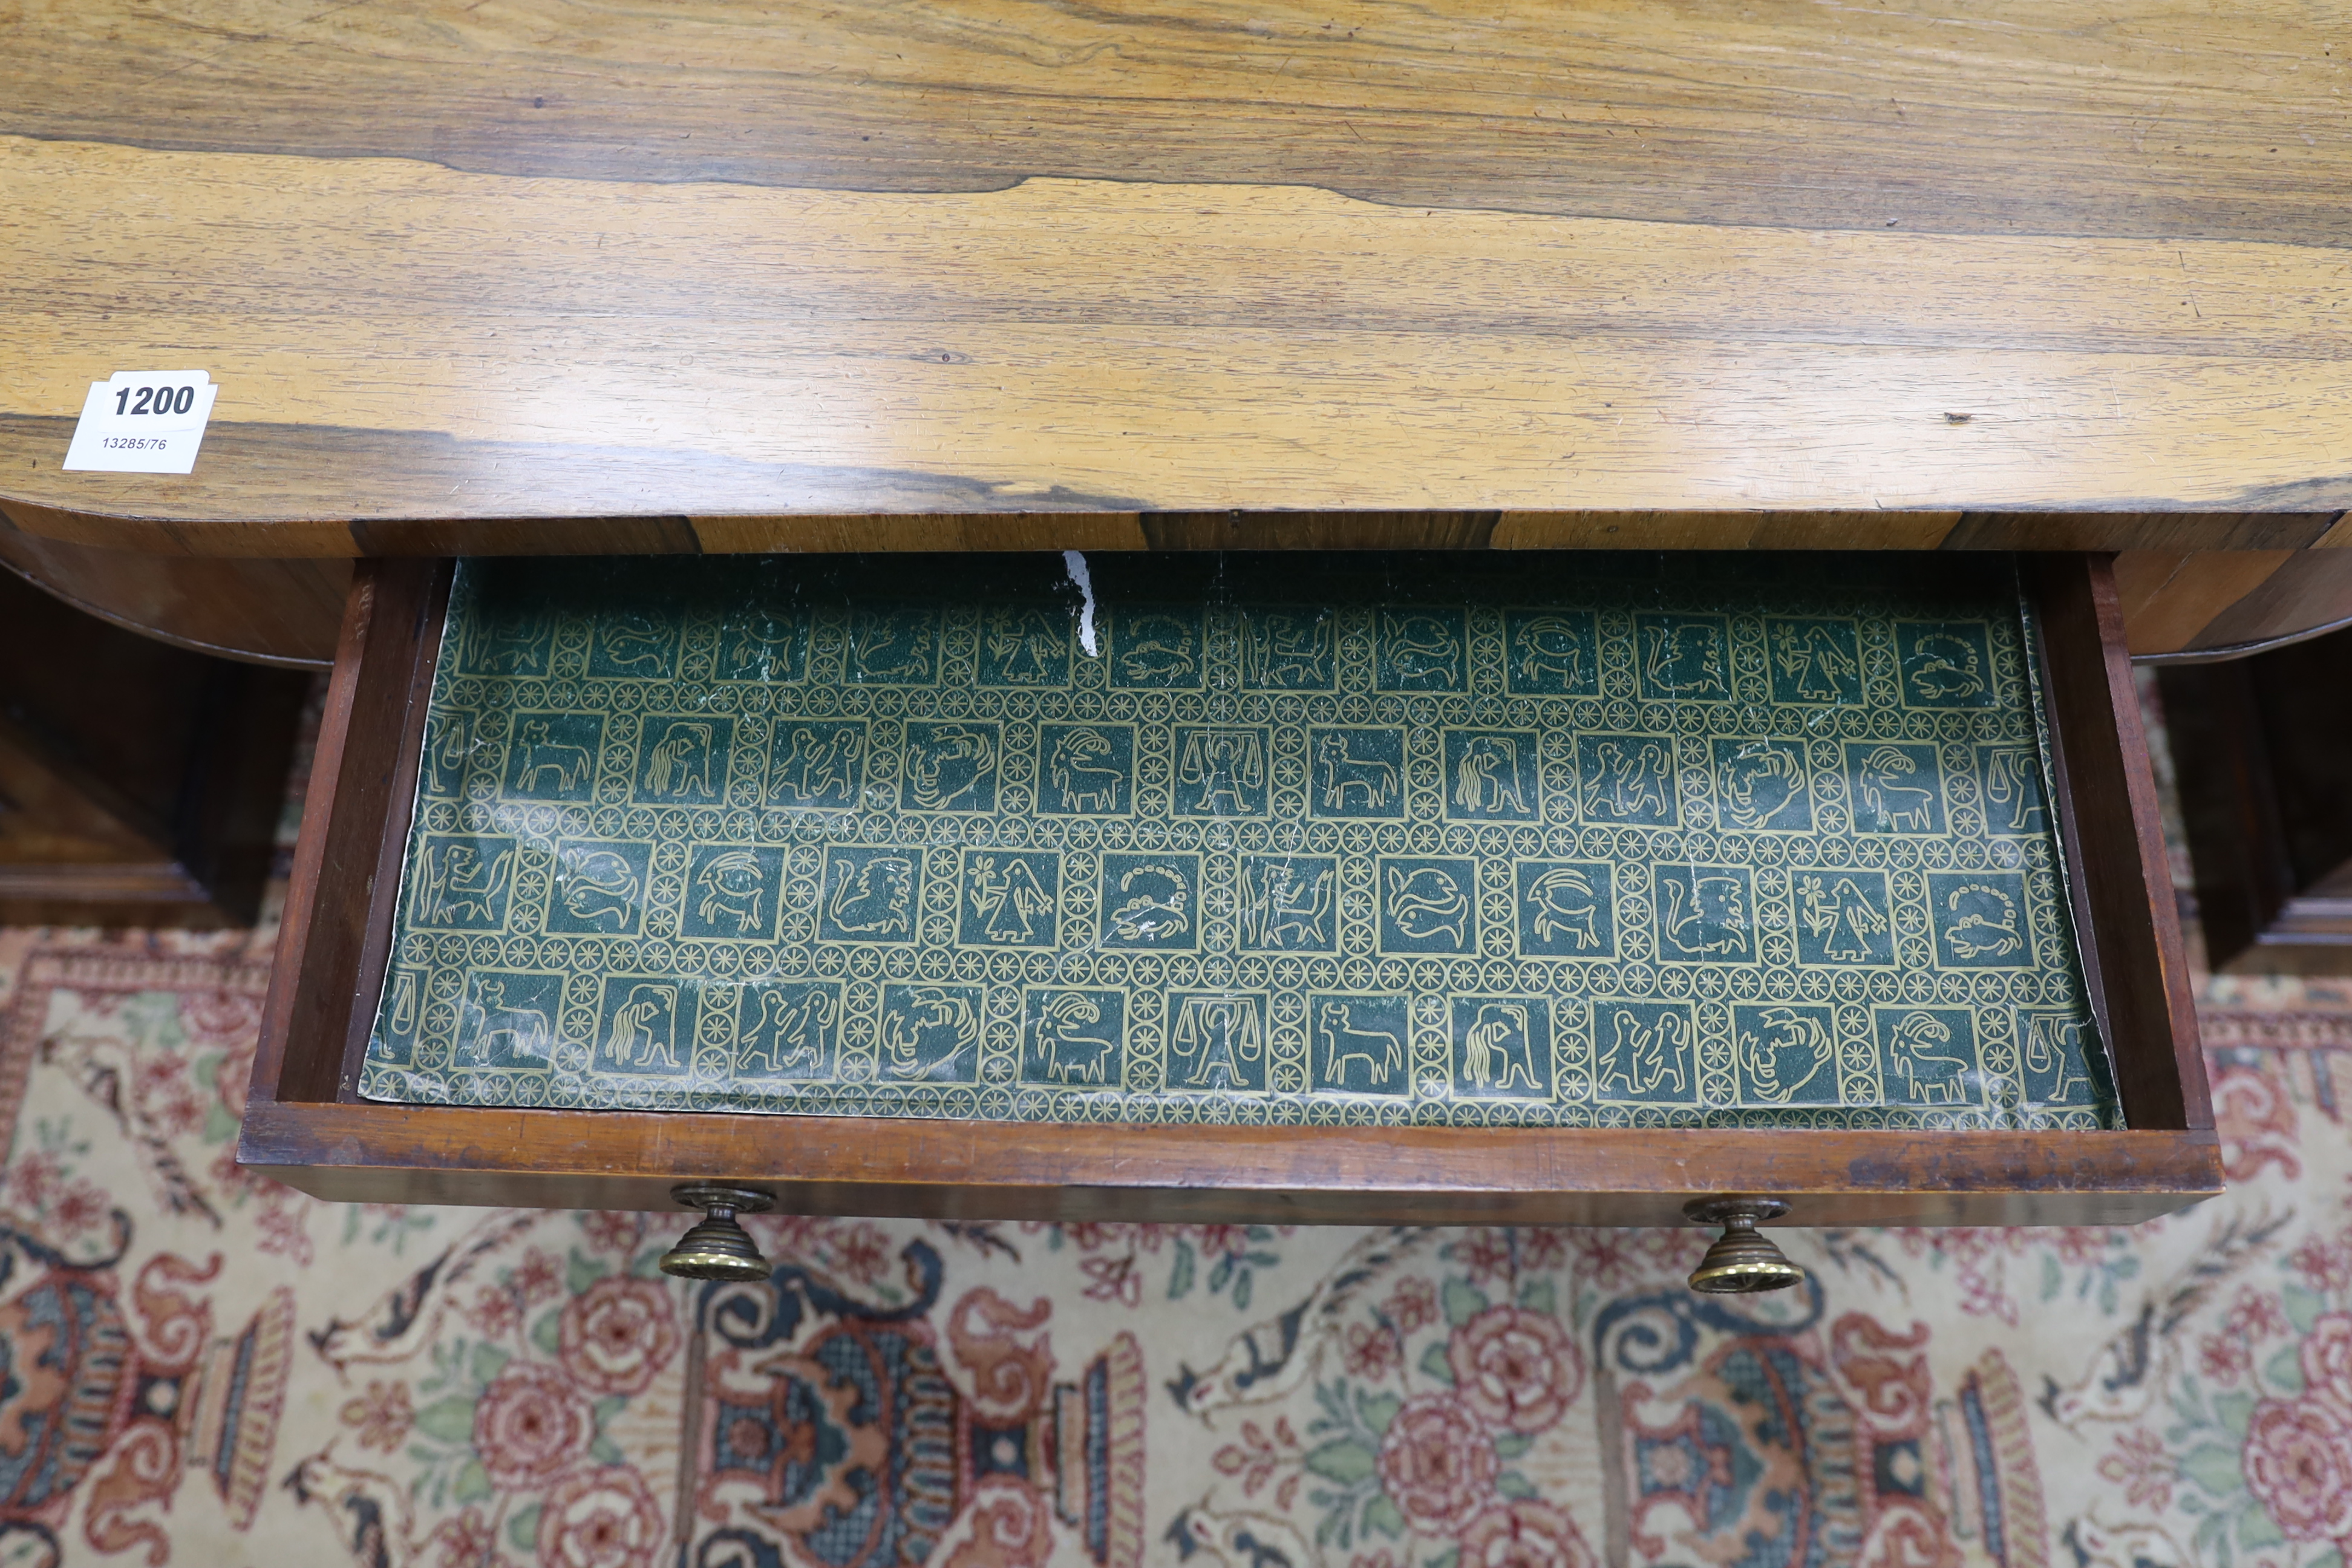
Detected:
left=240, top=555, right=2220, bottom=1250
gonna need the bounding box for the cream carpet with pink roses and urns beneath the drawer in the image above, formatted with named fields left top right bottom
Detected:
left=0, top=667, right=2352, bottom=1568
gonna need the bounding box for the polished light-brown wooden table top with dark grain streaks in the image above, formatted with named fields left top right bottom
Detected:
left=0, top=0, right=2352, bottom=555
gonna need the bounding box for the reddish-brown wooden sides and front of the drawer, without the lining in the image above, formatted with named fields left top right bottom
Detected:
left=238, top=555, right=2220, bottom=1225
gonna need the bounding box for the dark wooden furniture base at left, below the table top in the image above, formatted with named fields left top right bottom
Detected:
left=0, top=571, right=310, bottom=926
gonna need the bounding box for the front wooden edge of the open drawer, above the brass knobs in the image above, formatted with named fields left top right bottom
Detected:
left=238, top=1100, right=2223, bottom=1229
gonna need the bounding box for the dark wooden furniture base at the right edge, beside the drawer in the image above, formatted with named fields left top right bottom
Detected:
left=2157, top=632, right=2352, bottom=973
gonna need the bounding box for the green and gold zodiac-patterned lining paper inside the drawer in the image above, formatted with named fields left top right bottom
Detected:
left=360, top=555, right=2119, bottom=1128
